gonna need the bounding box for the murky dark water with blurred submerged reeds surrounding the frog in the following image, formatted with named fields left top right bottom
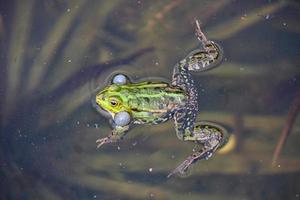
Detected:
left=0, top=0, right=300, bottom=200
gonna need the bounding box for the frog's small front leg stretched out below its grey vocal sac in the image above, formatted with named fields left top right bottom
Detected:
left=96, top=125, right=129, bottom=148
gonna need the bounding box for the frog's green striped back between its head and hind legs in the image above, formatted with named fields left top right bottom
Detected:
left=120, top=82, right=187, bottom=123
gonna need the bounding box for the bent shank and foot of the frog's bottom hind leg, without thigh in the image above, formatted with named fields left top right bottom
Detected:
left=168, top=121, right=227, bottom=177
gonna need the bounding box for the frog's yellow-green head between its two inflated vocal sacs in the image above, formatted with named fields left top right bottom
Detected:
left=96, top=84, right=128, bottom=118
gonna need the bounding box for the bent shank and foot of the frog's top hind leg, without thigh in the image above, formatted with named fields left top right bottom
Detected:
left=186, top=20, right=223, bottom=72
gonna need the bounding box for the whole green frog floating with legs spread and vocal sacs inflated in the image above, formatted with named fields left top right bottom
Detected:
left=95, top=20, right=227, bottom=177
